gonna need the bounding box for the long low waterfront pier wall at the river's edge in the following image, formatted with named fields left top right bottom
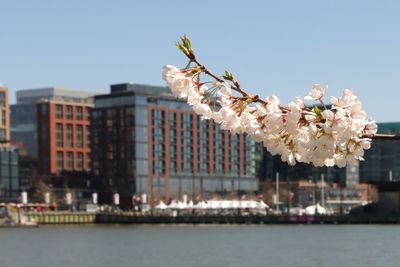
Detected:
left=19, top=212, right=400, bottom=225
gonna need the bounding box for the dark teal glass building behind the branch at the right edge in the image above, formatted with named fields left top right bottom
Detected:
left=360, top=122, right=400, bottom=183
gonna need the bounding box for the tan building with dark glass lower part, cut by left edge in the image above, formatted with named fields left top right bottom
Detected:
left=0, top=86, right=19, bottom=201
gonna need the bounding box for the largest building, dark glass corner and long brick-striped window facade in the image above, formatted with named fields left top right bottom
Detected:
left=91, top=84, right=258, bottom=206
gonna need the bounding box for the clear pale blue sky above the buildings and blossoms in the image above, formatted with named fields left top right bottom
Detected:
left=0, top=0, right=400, bottom=121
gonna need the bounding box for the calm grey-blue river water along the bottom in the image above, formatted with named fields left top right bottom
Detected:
left=0, top=225, right=400, bottom=267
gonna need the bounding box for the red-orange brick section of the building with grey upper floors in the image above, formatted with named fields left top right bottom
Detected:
left=37, top=101, right=93, bottom=175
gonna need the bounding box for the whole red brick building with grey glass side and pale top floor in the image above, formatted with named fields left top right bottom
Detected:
left=11, top=87, right=95, bottom=183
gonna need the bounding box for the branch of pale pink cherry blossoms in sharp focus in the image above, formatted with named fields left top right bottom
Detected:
left=163, top=36, right=400, bottom=167
